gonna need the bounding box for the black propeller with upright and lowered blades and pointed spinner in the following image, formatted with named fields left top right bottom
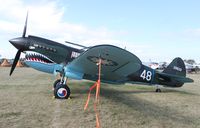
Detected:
left=9, top=12, right=28, bottom=76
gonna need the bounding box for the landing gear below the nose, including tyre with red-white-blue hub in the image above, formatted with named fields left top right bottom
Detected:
left=53, top=79, right=70, bottom=99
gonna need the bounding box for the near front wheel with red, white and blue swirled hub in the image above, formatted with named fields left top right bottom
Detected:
left=54, top=83, right=70, bottom=99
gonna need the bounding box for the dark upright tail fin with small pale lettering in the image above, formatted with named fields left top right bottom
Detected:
left=163, top=57, right=186, bottom=77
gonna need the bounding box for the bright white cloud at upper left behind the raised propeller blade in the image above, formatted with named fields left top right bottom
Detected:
left=0, top=0, right=117, bottom=40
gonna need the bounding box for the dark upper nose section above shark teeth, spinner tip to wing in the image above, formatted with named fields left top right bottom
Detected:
left=10, top=36, right=84, bottom=64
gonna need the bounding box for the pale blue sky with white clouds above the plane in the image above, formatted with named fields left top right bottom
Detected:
left=0, top=0, right=200, bottom=63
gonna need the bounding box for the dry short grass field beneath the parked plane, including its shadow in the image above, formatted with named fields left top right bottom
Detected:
left=0, top=68, right=200, bottom=128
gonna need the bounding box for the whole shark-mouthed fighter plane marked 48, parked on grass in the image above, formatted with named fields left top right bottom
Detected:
left=9, top=16, right=193, bottom=99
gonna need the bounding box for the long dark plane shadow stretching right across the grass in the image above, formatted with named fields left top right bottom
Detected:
left=102, top=88, right=198, bottom=125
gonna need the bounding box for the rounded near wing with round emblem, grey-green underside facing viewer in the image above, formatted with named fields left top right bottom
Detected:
left=67, top=45, right=142, bottom=82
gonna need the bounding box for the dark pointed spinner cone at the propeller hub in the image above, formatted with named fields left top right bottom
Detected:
left=9, top=38, right=25, bottom=49
